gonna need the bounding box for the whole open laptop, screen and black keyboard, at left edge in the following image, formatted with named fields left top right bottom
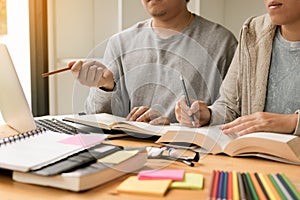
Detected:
left=0, top=43, right=126, bottom=139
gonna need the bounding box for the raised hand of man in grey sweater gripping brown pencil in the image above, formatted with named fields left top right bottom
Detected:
left=68, top=60, right=114, bottom=90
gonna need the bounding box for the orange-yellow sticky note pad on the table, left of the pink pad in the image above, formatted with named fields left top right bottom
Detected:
left=117, top=176, right=172, bottom=196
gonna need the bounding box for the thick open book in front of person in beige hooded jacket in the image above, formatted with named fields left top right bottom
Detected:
left=157, top=126, right=300, bottom=165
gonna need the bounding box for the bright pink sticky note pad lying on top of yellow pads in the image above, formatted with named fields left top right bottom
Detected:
left=138, top=170, right=184, bottom=181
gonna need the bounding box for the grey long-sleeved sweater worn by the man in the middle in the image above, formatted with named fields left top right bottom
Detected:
left=86, top=16, right=237, bottom=122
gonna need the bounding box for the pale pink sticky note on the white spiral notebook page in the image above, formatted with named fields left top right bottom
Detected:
left=59, top=134, right=105, bottom=147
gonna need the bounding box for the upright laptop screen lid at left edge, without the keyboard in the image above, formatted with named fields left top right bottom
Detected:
left=0, top=44, right=36, bottom=133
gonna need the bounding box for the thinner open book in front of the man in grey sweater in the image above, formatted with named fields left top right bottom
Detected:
left=64, top=113, right=179, bottom=136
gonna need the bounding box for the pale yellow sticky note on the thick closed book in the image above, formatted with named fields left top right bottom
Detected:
left=97, top=150, right=139, bottom=164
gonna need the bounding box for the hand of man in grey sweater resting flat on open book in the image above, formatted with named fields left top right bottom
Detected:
left=126, top=106, right=170, bottom=125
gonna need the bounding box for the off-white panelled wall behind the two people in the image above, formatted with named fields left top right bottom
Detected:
left=48, top=0, right=265, bottom=115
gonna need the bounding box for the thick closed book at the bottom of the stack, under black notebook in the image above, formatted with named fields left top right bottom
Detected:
left=13, top=149, right=147, bottom=192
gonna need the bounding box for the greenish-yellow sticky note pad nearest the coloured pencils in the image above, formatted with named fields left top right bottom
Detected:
left=170, top=173, right=204, bottom=190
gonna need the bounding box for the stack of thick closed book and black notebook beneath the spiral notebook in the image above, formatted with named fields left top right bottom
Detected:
left=13, top=144, right=147, bottom=192
